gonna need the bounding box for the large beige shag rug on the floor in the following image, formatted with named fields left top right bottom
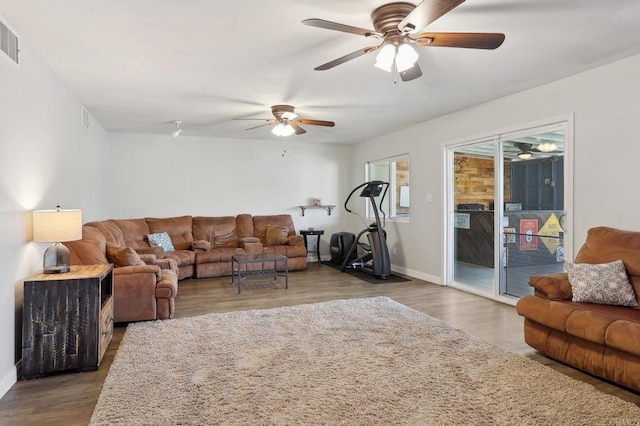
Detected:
left=91, top=297, right=640, bottom=425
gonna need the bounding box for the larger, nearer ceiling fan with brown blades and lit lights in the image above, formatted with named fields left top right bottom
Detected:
left=302, top=0, right=504, bottom=81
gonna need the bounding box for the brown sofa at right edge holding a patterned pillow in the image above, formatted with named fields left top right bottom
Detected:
left=517, top=227, right=640, bottom=391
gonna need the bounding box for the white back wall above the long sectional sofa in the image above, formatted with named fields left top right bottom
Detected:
left=108, top=133, right=351, bottom=250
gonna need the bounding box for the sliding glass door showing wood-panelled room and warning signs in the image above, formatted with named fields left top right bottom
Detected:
left=447, top=123, right=570, bottom=298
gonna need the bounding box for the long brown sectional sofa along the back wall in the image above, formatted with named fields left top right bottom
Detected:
left=64, top=214, right=307, bottom=322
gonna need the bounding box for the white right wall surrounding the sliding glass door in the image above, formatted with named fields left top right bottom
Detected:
left=352, top=56, right=640, bottom=282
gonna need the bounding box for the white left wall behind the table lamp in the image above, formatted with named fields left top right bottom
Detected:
left=0, top=20, right=107, bottom=396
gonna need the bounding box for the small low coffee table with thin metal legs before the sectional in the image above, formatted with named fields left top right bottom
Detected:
left=231, top=252, right=289, bottom=294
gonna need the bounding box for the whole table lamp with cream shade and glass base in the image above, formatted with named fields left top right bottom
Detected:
left=33, top=206, right=82, bottom=274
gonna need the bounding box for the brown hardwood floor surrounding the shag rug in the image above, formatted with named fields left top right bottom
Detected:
left=0, top=263, right=640, bottom=425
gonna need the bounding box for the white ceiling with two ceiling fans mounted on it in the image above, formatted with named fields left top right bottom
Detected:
left=0, top=0, right=640, bottom=143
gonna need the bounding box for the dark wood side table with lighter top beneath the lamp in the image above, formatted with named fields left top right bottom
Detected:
left=22, top=264, right=113, bottom=379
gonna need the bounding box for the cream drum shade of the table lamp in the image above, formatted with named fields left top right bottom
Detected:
left=33, top=208, right=82, bottom=243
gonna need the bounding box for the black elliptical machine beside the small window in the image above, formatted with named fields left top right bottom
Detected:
left=340, top=180, right=391, bottom=280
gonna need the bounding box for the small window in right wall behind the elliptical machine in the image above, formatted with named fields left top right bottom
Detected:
left=367, top=155, right=411, bottom=218
